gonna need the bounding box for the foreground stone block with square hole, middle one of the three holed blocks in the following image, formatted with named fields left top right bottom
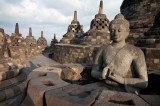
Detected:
left=22, top=75, right=68, bottom=106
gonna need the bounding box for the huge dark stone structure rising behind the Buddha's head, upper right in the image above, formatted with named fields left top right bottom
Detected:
left=121, top=0, right=160, bottom=44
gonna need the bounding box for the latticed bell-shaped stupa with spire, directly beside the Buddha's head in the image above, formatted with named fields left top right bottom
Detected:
left=81, top=0, right=110, bottom=45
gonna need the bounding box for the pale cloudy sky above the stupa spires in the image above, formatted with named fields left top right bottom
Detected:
left=0, top=0, right=123, bottom=44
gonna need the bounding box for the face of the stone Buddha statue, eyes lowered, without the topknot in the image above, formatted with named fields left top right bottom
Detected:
left=110, top=23, right=129, bottom=43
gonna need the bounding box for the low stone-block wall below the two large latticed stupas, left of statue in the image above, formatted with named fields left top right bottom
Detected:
left=52, top=44, right=99, bottom=64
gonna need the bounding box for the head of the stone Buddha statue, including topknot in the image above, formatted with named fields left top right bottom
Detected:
left=109, top=14, right=130, bottom=42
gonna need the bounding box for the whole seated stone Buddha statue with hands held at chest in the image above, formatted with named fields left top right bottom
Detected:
left=91, top=14, right=148, bottom=93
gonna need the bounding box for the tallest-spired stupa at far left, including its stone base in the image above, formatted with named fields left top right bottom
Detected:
left=7, top=23, right=26, bottom=66
